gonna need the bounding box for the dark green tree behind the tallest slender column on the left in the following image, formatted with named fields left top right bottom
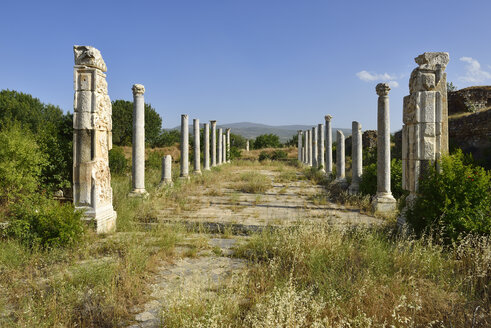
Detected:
left=112, top=100, right=162, bottom=147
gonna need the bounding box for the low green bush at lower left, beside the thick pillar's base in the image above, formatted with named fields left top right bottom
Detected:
left=7, top=196, right=84, bottom=248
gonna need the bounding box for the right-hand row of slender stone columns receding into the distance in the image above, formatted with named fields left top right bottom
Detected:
left=298, top=83, right=396, bottom=212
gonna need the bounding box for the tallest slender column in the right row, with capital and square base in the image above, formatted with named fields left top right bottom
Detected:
left=373, top=83, right=396, bottom=212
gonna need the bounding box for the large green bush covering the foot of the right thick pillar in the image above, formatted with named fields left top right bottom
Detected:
left=407, top=150, right=491, bottom=241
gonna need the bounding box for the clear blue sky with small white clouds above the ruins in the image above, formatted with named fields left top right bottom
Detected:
left=0, top=0, right=491, bottom=131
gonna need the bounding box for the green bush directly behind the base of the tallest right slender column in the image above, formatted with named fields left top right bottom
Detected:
left=360, top=158, right=407, bottom=198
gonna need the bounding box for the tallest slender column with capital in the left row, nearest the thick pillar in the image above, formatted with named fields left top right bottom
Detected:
left=130, top=84, right=148, bottom=196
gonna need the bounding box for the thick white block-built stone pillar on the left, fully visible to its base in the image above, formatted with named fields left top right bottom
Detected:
left=73, top=46, right=116, bottom=233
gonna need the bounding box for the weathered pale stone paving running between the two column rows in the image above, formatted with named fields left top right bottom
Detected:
left=131, top=167, right=380, bottom=328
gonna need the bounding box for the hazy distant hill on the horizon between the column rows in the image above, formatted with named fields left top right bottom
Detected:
left=174, top=122, right=351, bottom=142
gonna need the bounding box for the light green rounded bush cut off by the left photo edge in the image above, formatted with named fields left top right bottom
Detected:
left=0, top=124, right=47, bottom=204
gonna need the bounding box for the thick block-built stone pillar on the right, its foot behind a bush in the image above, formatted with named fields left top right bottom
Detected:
left=402, top=52, right=449, bottom=206
